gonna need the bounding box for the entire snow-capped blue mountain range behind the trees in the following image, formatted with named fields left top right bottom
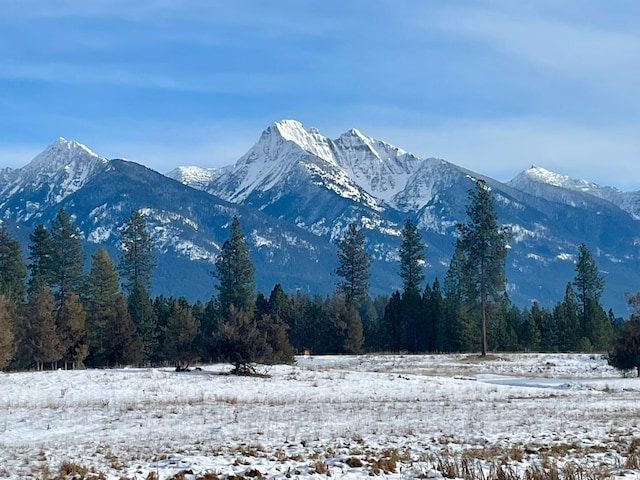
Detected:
left=0, top=120, right=640, bottom=315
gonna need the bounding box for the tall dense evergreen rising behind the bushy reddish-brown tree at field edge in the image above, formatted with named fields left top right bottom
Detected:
left=214, top=216, right=255, bottom=316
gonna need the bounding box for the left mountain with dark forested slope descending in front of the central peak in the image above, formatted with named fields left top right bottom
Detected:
left=0, top=142, right=335, bottom=301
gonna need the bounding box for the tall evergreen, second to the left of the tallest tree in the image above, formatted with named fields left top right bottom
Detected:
left=336, top=223, right=371, bottom=304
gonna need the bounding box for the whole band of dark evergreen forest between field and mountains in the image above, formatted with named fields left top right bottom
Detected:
left=0, top=181, right=640, bottom=373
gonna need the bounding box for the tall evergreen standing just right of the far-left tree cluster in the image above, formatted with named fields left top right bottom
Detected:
left=118, top=210, right=156, bottom=292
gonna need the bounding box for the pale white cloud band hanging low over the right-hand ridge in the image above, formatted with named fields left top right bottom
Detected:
left=368, top=118, right=640, bottom=190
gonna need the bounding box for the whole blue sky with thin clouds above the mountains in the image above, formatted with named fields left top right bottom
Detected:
left=0, top=0, right=640, bottom=190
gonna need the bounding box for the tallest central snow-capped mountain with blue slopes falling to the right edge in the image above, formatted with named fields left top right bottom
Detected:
left=169, top=120, right=640, bottom=305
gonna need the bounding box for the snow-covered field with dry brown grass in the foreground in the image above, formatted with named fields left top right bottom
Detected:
left=0, top=354, right=640, bottom=480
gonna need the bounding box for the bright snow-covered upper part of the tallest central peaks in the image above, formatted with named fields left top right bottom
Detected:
left=168, top=120, right=443, bottom=213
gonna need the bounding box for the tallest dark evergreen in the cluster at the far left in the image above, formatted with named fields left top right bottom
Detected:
left=45, top=209, right=84, bottom=305
